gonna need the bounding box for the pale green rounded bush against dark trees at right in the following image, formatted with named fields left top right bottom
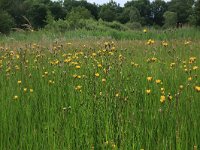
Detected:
left=163, top=11, right=177, bottom=28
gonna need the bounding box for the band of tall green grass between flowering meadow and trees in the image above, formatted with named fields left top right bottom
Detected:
left=0, top=27, right=200, bottom=43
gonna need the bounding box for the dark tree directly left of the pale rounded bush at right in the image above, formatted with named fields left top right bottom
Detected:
left=151, top=0, right=167, bottom=26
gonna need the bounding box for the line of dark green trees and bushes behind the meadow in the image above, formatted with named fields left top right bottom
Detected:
left=0, top=0, right=200, bottom=33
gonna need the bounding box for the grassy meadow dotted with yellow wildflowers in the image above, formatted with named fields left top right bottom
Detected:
left=0, top=29, right=200, bottom=150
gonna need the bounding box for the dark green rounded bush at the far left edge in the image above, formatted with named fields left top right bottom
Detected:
left=0, top=10, right=14, bottom=34
